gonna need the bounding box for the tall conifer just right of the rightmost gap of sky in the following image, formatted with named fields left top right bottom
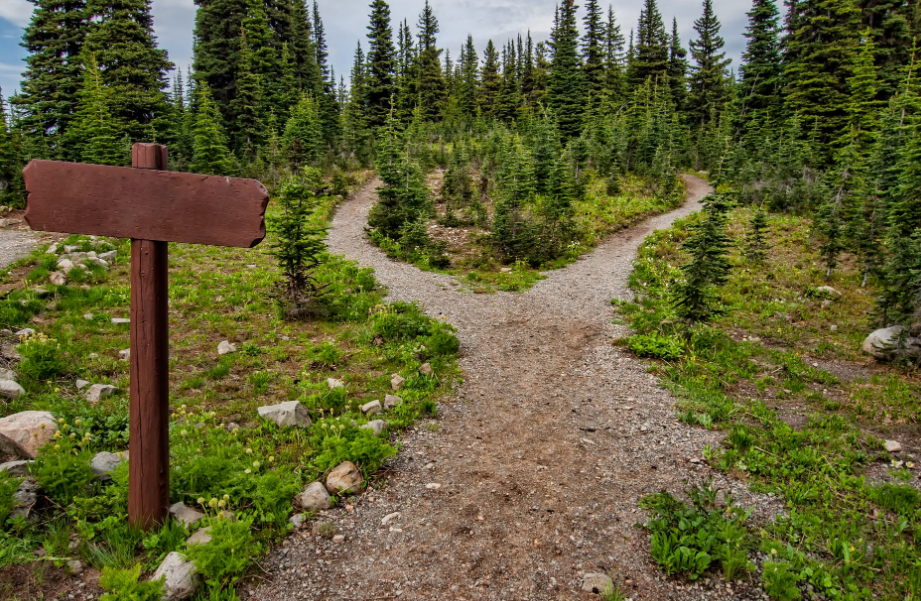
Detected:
left=739, top=0, right=783, bottom=131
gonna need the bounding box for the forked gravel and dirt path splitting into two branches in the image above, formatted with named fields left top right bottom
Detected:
left=242, top=177, right=762, bottom=601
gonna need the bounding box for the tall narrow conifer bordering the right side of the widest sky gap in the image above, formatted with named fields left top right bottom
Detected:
left=546, top=0, right=585, bottom=139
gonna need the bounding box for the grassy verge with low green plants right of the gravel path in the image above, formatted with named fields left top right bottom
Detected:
left=620, top=209, right=921, bottom=601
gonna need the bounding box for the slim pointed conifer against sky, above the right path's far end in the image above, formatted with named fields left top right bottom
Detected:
left=689, top=0, right=731, bottom=125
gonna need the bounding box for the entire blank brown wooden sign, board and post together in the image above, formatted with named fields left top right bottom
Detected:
left=22, top=144, right=269, bottom=529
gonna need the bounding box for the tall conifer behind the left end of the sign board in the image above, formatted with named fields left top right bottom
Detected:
left=13, top=0, right=89, bottom=158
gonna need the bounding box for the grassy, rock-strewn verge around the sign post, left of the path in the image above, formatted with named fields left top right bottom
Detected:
left=0, top=180, right=459, bottom=601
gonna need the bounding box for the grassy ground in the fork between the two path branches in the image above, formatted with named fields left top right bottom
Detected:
left=372, top=174, right=685, bottom=294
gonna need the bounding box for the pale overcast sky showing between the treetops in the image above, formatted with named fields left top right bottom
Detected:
left=0, top=0, right=750, bottom=97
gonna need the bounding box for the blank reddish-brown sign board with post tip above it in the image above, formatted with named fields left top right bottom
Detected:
left=22, top=158, right=269, bottom=248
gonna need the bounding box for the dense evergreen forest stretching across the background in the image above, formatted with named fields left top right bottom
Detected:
left=0, top=0, right=921, bottom=324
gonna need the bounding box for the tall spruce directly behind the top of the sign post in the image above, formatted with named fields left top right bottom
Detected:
left=86, top=0, right=174, bottom=141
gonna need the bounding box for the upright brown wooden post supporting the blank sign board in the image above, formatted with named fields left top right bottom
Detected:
left=128, top=144, right=169, bottom=530
